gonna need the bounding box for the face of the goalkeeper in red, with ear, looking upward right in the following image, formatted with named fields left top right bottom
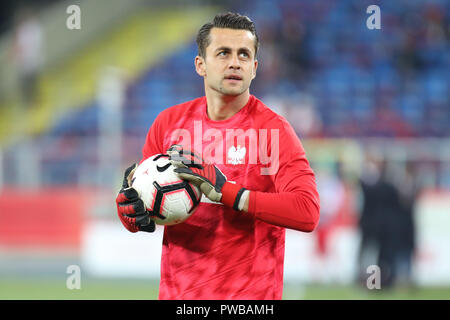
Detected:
left=195, top=28, right=258, bottom=96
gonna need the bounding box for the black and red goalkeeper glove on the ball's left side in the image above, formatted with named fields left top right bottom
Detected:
left=116, top=163, right=155, bottom=232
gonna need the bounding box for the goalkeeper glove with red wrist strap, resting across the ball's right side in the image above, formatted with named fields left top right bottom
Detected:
left=167, top=145, right=246, bottom=210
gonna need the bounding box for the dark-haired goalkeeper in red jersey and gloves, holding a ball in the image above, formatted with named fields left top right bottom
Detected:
left=116, top=13, right=320, bottom=300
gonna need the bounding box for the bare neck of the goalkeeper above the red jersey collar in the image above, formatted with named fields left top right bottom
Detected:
left=206, top=90, right=250, bottom=121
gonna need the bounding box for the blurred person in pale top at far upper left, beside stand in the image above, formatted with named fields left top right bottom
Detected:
left=12, top=7, right=44, bottom=108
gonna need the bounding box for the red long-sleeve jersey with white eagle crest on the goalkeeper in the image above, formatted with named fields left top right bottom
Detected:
left=129, top=95, right=319, bottom=299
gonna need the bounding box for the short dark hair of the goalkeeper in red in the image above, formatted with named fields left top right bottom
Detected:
left=197, top=12, right=259, bottom=58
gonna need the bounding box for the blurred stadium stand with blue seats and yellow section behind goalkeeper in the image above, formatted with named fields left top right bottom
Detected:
left=0, top=0, right=450, bottom=184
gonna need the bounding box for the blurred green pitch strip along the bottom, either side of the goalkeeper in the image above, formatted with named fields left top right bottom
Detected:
left=0, top=277, right=450, bottom=300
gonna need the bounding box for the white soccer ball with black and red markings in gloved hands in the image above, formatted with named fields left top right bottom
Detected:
left=131, top=154, right=202, bottom=225
